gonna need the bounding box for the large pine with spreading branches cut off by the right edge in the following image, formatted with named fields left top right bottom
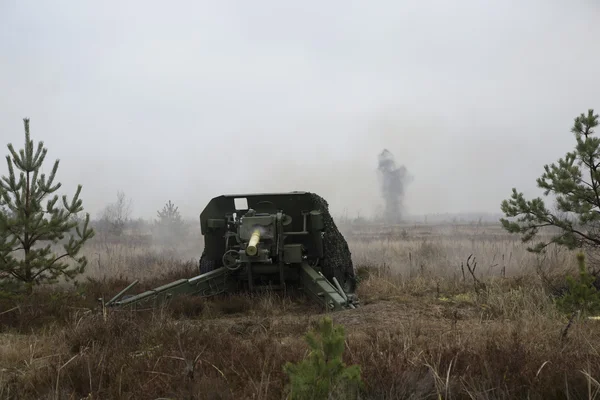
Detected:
left=500, top=109, right=600, bottom=253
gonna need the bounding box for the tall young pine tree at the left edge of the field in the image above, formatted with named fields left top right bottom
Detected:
left=0, top=118, right=94, bottom=292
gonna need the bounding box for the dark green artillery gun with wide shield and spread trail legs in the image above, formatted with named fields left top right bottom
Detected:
left=106, top=192, right=358, bottom=311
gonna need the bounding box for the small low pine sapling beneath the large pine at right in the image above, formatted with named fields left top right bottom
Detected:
left=556, top=253, right=600, bottom=316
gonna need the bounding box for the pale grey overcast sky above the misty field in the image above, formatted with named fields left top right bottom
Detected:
left=0, top=0, right=600, bottom=218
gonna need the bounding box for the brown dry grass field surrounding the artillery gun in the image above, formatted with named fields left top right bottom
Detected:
left=0, top=224, right=600, bottom=399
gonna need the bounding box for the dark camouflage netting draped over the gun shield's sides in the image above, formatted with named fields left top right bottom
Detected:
left=200, top=193, right=356, bottom=292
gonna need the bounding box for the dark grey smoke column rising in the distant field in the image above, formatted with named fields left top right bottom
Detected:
left=377, top=149, right=409, bottom=223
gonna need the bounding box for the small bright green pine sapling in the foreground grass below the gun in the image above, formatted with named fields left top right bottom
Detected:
left=284, top=317, right=363, bottom=400
